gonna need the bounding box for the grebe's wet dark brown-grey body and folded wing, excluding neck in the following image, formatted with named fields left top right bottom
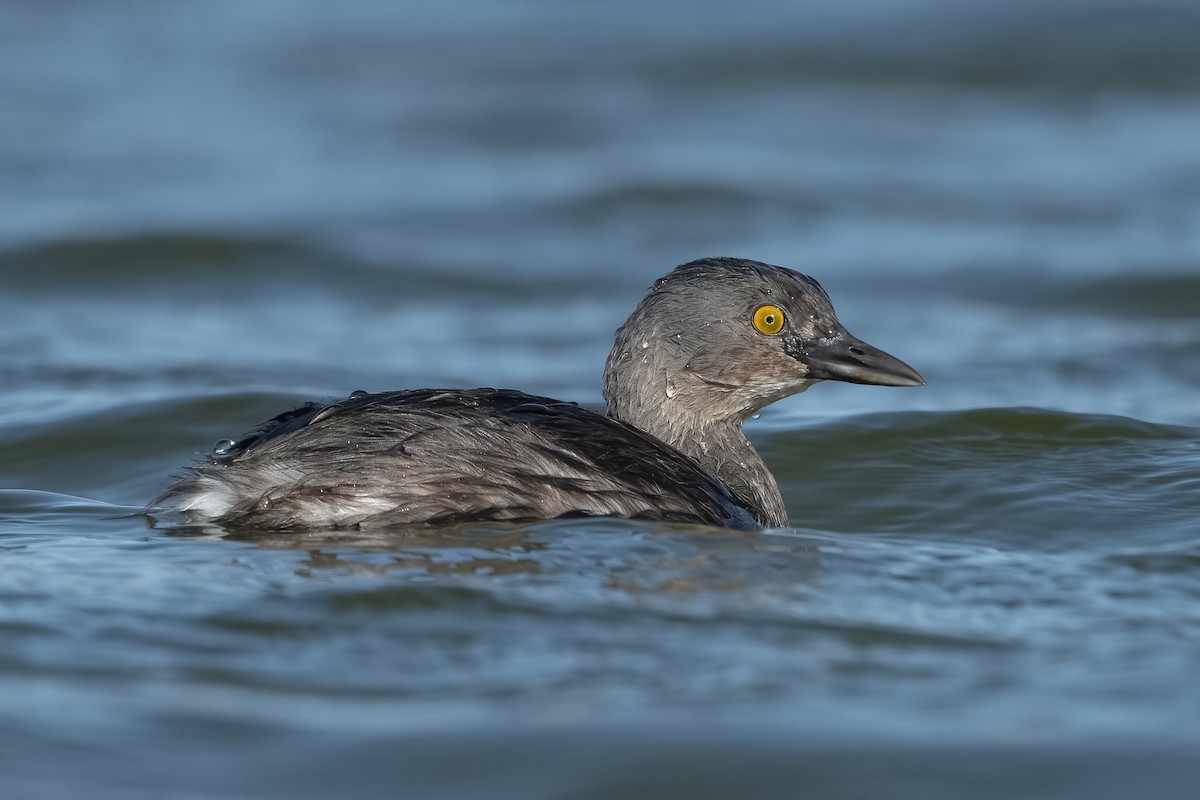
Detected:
left=156, top=389, right=755, bottom=529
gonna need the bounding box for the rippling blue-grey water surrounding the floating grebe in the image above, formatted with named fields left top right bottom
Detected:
left=0, top=0, right=1200, bottom=798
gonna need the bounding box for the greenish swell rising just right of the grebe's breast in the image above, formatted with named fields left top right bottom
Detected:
left=761, top=408, right=1200, bottom=549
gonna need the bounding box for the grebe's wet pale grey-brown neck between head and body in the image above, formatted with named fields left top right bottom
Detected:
left=605, top=371, right=787, bottom=528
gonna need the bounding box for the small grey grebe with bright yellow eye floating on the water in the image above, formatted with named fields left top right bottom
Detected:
left=150, top=258, right=924, bottom=530
